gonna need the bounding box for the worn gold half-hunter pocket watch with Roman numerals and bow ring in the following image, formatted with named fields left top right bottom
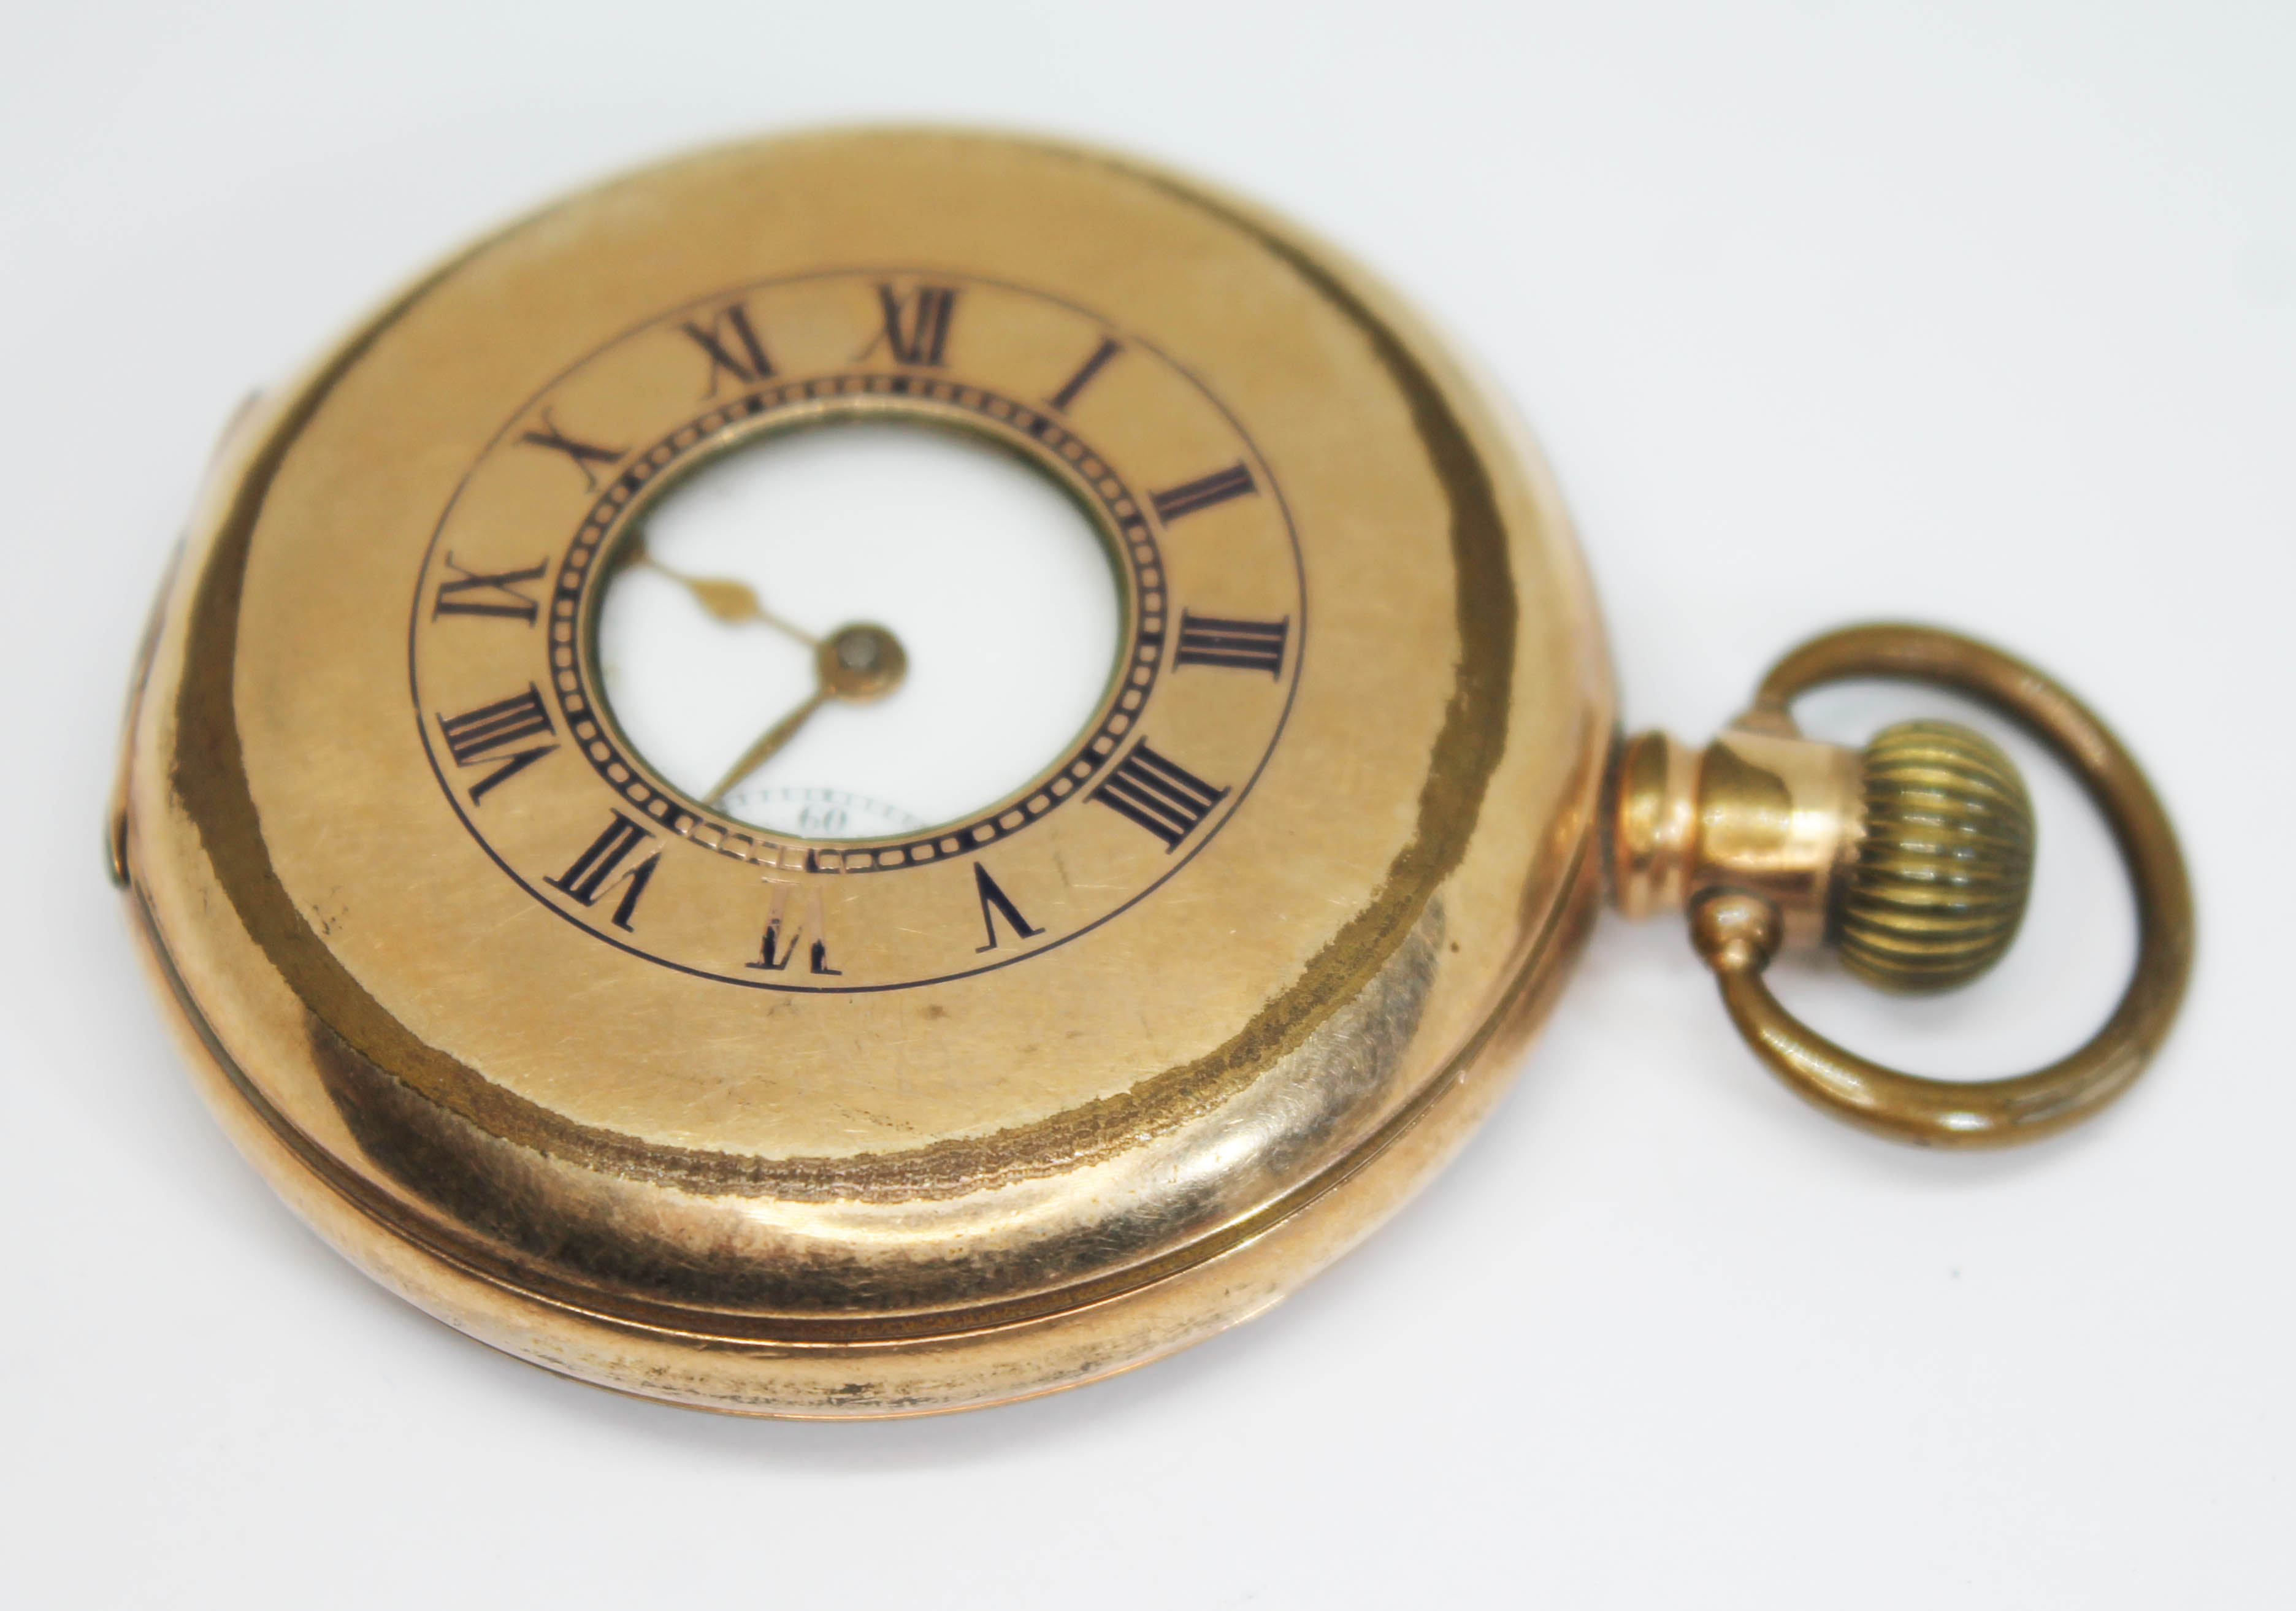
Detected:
left=110, top=131, right=2191, bottom=1416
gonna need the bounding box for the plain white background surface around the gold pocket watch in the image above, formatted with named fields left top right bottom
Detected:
left=0, top=0, right=2296, bottom=1607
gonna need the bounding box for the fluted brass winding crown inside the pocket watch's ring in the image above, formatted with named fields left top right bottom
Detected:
left=1834, top=721, right=2032, bottom=992
